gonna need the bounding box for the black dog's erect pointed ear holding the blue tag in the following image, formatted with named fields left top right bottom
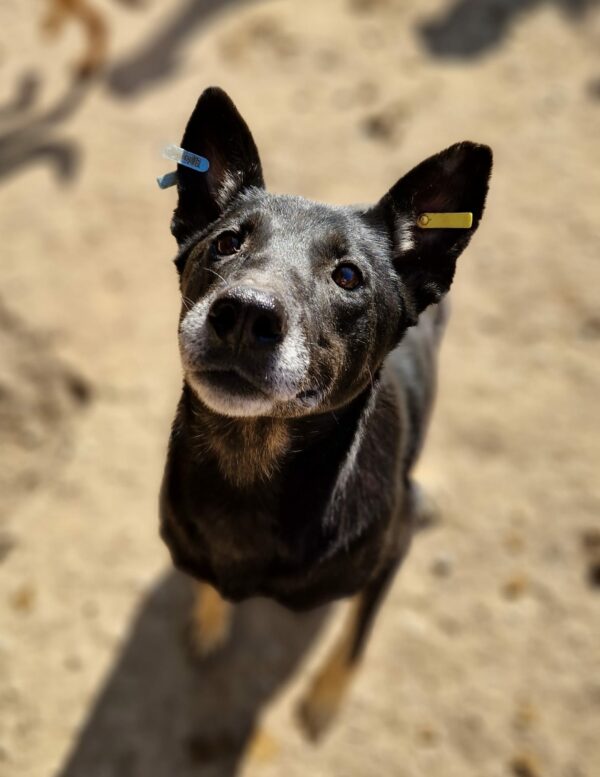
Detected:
left=171, top=87, right=264, bottom=244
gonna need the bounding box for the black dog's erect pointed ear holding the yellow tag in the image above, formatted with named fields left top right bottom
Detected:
left=372, top=141, right=492, bottom=317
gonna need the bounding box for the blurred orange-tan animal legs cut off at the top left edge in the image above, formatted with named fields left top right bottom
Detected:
left=42, top=0, right=142, bottom=79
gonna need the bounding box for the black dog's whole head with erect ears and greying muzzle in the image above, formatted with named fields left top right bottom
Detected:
left=172, top=88, right=492, bottom=417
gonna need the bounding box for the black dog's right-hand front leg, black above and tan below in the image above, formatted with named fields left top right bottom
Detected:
left=298, top=562, right=398, bottom=741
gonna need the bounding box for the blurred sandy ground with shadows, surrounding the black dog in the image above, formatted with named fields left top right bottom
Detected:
left=0, top=0, right=600, bottom=777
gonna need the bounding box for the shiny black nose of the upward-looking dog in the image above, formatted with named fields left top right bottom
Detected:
left=208, top=286, right=286, bottom=348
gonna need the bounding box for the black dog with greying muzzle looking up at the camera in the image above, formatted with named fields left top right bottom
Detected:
left=160, top=88, right=492, bottom=739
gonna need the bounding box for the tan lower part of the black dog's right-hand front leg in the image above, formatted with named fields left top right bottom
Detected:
left=298, top=594, right=362, bottom=741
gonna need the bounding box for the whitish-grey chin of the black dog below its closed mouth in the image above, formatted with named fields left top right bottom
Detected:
left=186, top=370, right=290, bottom=418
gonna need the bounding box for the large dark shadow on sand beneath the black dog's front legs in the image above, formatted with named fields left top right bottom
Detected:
left=60, top=573, right=328, bottom=777
